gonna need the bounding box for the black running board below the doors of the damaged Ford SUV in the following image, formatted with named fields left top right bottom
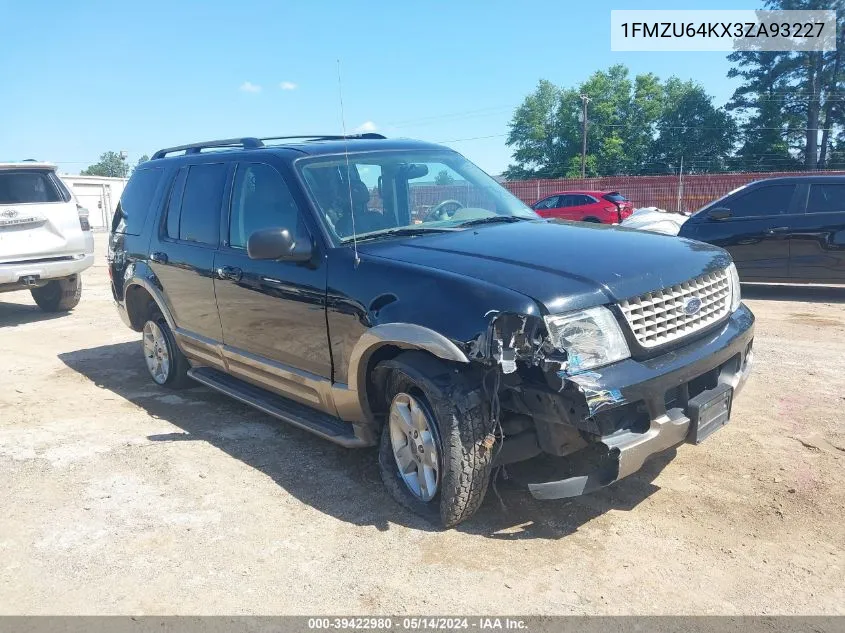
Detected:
left=188, top=367, right=371, bottom=448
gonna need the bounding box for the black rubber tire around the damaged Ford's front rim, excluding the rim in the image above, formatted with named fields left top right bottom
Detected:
left=375, top=352, right=493, bottom=528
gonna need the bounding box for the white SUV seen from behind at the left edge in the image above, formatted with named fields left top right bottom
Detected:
left=0, top=161, right=94, bottom=312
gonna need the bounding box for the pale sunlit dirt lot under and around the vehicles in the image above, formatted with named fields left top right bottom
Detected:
left=0, top=240, right=845, bottom=614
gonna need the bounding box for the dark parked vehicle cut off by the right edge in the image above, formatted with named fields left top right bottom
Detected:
left=679, top=176, right=845, bottom=284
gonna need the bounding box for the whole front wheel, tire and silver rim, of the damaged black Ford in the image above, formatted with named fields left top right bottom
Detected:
left=376, top=352, right=493, bottom=528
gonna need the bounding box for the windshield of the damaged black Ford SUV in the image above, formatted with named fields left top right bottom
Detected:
left=297, top=150, right=539, bottom=244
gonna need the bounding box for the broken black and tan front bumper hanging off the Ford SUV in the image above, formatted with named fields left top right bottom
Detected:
left=525, top=306, right=754, bottom=499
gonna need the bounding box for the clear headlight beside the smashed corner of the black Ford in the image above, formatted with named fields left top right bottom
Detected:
left=545, top=307, right=631, bottom=372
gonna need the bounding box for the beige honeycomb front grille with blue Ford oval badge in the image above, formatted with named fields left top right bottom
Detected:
left=619, top=270, right=731, bottom=348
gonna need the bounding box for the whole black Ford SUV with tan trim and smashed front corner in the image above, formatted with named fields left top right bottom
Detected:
left=109, top=135, right=754, bottom=526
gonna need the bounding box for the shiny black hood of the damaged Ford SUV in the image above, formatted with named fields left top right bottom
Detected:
left=359, top=221, right=730, bottom=313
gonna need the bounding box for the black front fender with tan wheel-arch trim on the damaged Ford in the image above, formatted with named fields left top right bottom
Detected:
left=326, top=249, right=542, bottom=423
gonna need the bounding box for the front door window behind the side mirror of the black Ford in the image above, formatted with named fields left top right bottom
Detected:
left=229, top=163, right=301, bottom=248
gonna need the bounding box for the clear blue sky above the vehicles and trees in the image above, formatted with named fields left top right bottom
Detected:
left=0, top=0, right=762, bottom=174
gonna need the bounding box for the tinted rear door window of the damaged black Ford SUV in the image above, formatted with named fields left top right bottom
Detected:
left=179, top=163, right=228, bottom=246
